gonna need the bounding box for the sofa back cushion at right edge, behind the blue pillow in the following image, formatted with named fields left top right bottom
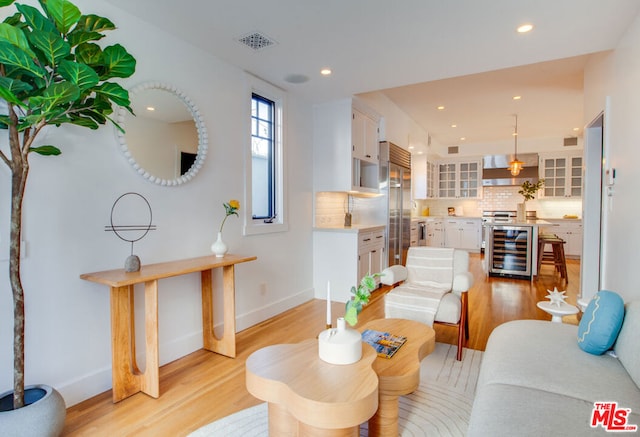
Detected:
left=614, top=301, right=640, bottom=386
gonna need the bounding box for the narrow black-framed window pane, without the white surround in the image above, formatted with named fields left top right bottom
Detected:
left=251, top=93, right=276, bottom=223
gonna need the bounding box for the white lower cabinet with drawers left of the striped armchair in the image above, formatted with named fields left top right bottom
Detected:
left=313, top=226, right=386, bottom=302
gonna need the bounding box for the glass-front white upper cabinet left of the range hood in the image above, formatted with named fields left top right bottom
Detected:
left=438, top=160, right=482, bottom=199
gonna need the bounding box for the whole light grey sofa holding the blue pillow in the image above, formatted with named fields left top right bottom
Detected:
left=468, top=301, right=640, bottom=437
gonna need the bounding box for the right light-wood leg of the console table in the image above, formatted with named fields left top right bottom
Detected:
left=200, top=265, right=236, bottom=358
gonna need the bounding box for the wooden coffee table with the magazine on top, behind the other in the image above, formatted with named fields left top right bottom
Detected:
left=360, top=319, right=436, bottom=436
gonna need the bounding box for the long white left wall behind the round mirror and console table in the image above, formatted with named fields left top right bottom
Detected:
left=0, top=0, right=322, bottom=405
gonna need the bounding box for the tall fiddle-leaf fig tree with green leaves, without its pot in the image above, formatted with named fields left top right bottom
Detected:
left=0, top=0, right=136, bottom=410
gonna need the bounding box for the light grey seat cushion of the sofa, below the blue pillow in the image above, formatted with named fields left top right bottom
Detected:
left=478, top=320, right=640, bottom=408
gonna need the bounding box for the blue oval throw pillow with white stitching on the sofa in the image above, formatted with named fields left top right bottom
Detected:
left=578, top=290, right=624, bottom=355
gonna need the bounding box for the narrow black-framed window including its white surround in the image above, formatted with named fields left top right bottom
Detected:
left=244, top=76, right=287, bottom=235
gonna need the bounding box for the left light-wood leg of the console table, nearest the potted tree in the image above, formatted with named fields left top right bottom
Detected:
left=111, top=281, right=160, bottom=402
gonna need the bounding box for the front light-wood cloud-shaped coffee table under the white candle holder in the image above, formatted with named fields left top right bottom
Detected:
left=246, top=339, right=378, bottom=437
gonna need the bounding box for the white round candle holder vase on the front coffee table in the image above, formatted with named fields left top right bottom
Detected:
left=318, top=317, right=362, bottom=364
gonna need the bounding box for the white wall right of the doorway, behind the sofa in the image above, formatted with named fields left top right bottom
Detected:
left=585, top=11, right=640, bottom=301
